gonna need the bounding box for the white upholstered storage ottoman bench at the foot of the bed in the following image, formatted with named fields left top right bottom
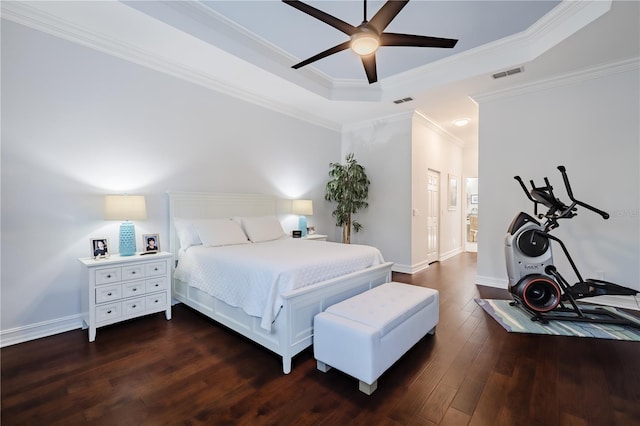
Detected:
left=313, top=282, right=439, bottom=395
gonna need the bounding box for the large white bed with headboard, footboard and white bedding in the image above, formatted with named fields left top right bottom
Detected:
left=168, top=192, right=392, bottom=374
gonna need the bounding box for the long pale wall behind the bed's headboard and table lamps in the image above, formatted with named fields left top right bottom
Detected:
left=1, top=20, right=341, bottom=344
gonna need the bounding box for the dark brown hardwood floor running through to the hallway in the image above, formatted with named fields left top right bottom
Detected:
left=0, top=253, right=640, bottom=426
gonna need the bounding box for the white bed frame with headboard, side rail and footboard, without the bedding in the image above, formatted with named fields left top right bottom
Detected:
left=168, top=192, right=393, bottom=374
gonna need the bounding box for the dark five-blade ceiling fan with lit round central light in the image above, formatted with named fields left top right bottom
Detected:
left=282, top=0, right=458, bottom=84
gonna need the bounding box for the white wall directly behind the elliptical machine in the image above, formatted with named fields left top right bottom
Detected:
left=477, top=59, right=640, bottom=290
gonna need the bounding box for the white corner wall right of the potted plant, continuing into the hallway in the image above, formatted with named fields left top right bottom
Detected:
left=335, top=113, right=463, bottom=273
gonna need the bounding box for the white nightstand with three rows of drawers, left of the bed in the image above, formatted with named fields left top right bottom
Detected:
left=78, top=252, right=173, bottom=342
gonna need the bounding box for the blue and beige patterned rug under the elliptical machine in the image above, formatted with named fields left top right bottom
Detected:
left=475, top=299, right=640, bottom=342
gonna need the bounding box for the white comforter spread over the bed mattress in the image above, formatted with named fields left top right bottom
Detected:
left=175, top=238, right=384, bottom=330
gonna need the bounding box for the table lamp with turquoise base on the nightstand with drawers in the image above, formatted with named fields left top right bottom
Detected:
left=104, top=195, right=147, bottom=256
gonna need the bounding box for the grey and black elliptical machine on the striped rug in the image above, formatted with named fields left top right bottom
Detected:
left=505, top=166, right=640, bottom=328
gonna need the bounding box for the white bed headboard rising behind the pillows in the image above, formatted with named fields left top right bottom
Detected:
left=167, top=192, right=278, bottom=260
